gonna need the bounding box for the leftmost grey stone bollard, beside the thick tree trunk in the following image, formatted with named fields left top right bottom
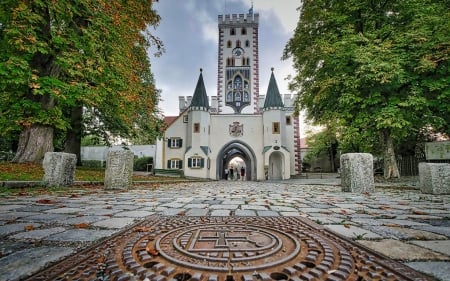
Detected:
left=42, top=152, right=77, bottom=186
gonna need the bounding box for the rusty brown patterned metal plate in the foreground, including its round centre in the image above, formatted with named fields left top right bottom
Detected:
left=28, top=216, right=429, bottom=281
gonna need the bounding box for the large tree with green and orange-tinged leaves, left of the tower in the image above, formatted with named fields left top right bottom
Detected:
left=0, top=0, right=162, bottom=162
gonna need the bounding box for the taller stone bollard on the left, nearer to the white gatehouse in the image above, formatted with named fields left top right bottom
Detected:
left=105, top=150, right=134, bottom=189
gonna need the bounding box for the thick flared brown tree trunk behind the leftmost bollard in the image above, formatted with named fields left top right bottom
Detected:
left=12, top=124, right=53, bottom=164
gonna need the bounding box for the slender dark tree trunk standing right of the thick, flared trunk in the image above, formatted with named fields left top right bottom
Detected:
left=64, top=106, right=83, bottom=166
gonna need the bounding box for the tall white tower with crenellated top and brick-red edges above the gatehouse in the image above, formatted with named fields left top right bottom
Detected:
left=217, top=10, right=259, bottom=114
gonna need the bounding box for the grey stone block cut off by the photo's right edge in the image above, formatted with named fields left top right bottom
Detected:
left=419, top=163, right=450, bottom=194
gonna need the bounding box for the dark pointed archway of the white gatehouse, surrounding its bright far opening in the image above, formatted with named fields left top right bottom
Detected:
left=216, top=141, right=256, bottom=180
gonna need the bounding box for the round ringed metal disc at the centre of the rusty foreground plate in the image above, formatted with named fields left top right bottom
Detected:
left=155, top=224, right=300, bottom=272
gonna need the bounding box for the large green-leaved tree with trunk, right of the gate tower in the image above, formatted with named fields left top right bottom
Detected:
left=284, top=0, right=450, bottom=178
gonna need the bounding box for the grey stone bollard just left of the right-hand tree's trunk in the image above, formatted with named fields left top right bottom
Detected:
left=341, top=153, right=375, bottom=193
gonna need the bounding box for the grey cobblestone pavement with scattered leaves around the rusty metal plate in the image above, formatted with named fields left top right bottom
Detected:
left=0, top=179, right=450, bottom=280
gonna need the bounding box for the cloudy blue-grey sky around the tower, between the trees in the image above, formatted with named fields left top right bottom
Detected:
left=150, top=0, right=300, bottom=116
